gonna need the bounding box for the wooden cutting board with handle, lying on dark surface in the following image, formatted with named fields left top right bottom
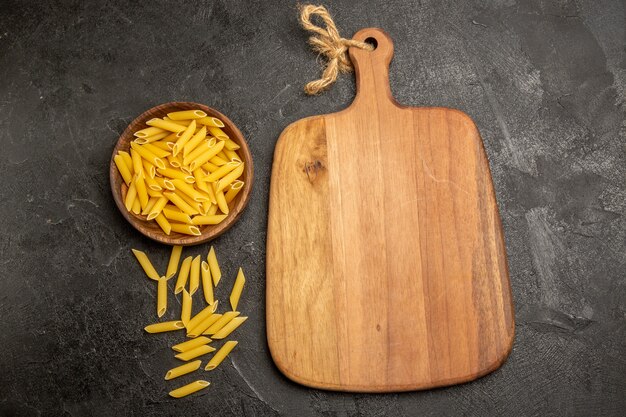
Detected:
left=267, top=29, right=514, bottom=392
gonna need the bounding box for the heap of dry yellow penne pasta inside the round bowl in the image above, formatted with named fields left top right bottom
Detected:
left=113, top=110, right=246, bottom=234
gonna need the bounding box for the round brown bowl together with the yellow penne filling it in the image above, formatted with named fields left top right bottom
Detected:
left=109, top=102, right=253, bottom=245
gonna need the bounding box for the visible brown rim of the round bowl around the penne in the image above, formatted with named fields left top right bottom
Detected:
left=109, top=102, right=253, bottom=246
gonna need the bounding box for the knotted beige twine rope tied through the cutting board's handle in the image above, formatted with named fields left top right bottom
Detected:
left=300, top=4, right=374, bottom=95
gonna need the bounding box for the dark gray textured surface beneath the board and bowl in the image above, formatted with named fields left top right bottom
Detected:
left=0, top=0, right=626, bottom=416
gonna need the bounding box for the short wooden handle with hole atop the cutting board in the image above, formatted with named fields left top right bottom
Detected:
left=348, top=28, right=397, bottom=107
